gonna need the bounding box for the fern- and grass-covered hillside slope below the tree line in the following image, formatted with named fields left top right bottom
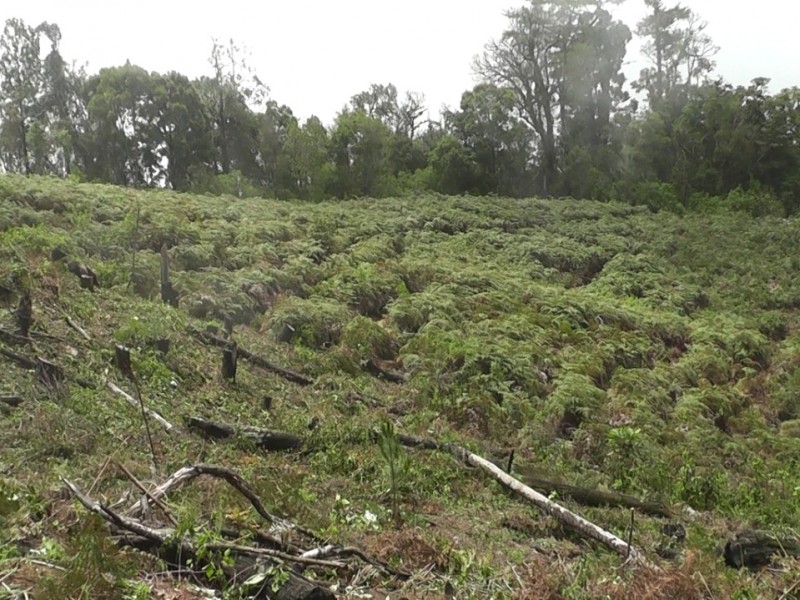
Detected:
left=0, top=176, right=800, bottom=598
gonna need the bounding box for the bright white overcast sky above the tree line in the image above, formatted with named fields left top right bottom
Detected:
left=0, top=0, right=800, bottom=124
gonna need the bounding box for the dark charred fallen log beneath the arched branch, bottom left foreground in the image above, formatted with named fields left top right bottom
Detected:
left=62, top=479, right=334, bottom=600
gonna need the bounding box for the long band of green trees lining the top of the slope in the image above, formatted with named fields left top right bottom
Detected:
left=0, top=0, right=800, bottom=215
